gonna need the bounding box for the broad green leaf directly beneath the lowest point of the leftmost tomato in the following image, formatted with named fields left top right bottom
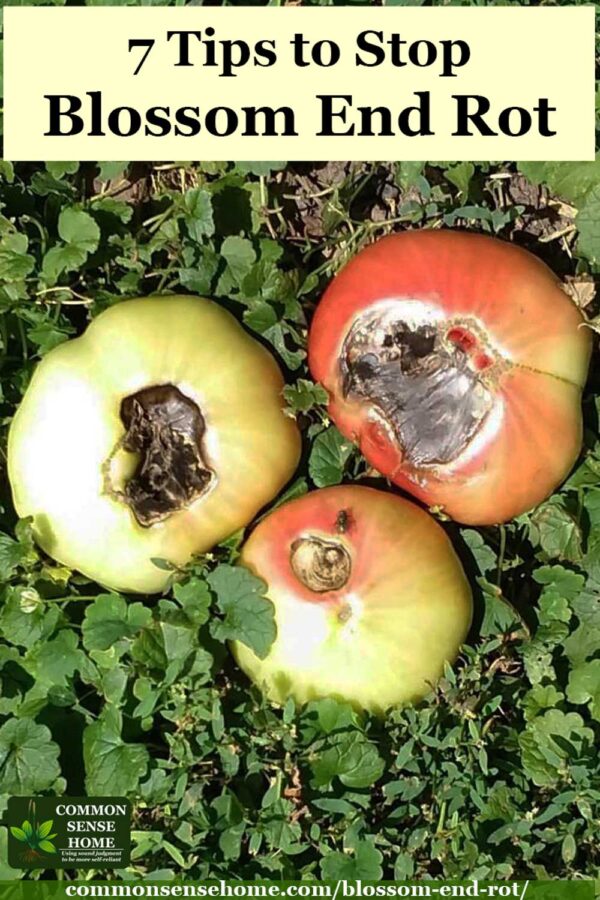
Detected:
left=81, top=594, right=152, bottom=650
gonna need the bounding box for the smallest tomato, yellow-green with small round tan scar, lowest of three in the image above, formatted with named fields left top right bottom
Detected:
left=233, top=485, right=471, bottom=713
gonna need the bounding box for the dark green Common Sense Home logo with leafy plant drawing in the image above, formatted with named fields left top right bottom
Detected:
left=7, top=797, right=131, bottom=869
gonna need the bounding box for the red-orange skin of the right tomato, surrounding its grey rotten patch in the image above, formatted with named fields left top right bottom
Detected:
left=309, top=230, right=591, bottom=525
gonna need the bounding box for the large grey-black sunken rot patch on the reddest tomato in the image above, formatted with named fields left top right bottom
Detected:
left=340, top=306, right=494, bottom=466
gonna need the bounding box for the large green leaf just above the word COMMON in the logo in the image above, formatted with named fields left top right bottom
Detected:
left=83, top=705, right=149, bottom=797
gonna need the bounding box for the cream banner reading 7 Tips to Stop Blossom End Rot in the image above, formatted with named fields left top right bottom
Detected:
left=4, top=6, right=594, bottom=161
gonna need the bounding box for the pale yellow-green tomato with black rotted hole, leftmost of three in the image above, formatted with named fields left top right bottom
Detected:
left=8, top=296, right=300, bottom=592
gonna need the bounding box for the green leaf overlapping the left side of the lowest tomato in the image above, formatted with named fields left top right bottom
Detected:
left=207, top=565, right=277, bottom=659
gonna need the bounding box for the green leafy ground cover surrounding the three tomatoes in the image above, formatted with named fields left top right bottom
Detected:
left=0, top=0, right=600, bottom=879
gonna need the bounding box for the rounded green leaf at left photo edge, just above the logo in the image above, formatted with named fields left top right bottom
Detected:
left=0, top=719, right=60, bottom=794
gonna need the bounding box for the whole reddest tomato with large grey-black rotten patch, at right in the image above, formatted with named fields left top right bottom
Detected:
left=309, top=230, right=591, bottom=525
